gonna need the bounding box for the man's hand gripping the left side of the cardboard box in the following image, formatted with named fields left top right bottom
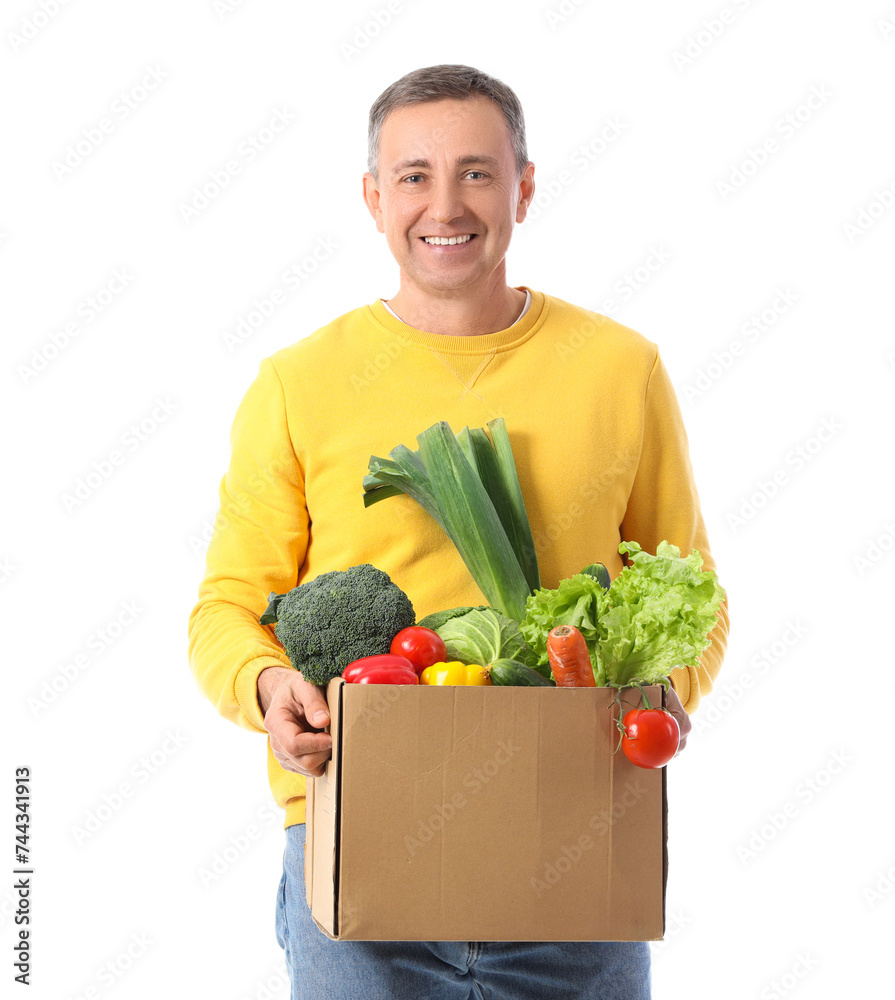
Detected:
left=258, top=667, right=333, bottom=778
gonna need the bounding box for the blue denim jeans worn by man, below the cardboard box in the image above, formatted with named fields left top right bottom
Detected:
left=276, top=823, right=650, bottom=1000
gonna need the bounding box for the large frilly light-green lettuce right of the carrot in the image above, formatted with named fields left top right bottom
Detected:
left=599, top=542, right=725, bottom=685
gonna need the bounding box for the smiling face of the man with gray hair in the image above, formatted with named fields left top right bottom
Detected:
left=364, top=96, right=534, bottom=293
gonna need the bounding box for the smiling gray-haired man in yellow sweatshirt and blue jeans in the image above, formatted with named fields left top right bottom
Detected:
left=190, top=66, right=727, bottom=1000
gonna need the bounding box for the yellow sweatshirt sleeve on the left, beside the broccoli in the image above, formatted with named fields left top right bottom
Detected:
left=189, top=359, right=310, bottom=732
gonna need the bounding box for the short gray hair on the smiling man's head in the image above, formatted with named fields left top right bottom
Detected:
left=367, top=64, right=528, bottom=184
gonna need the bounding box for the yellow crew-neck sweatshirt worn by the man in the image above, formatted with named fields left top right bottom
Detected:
left=189, top=286, right=728, bottom=826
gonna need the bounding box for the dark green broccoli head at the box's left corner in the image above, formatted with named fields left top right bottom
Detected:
left=260, top=563, right=416, bottom=684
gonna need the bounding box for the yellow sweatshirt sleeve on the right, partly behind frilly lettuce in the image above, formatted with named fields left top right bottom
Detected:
left=621, top=352, right=729, bottom=714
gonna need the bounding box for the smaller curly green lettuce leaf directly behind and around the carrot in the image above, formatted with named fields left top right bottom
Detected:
left=520, top=572, right=607, bottom=686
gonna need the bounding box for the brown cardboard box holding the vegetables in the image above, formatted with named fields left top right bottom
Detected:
left=305, top=679, right=667, bottom=941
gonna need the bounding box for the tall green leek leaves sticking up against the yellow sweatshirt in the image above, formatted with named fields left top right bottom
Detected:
left=363, top=417, right=540, bottom=622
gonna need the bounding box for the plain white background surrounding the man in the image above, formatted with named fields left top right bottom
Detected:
left=0, top=0, right=895, bottom=1000
